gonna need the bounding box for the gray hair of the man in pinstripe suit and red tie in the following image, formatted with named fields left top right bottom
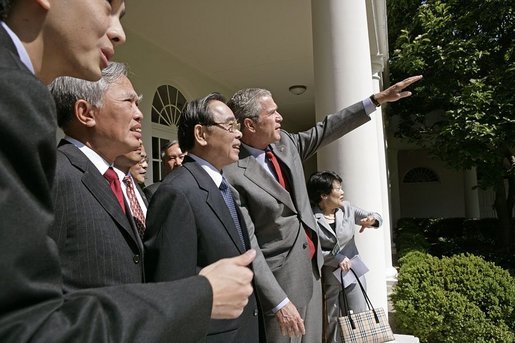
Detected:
left=48, top=62, right=128, bottom=128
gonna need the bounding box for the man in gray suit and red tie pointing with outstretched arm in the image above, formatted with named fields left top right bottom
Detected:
left=224, top=76, right=421, bottom=343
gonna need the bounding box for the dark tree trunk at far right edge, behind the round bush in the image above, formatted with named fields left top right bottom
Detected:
left=494, top=179, right=513, bottom=252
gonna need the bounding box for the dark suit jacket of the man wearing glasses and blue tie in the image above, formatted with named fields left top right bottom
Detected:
left=145, top=156, right=258, bottom=343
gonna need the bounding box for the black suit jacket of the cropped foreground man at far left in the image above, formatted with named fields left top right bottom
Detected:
left=0, top=26, right=212, bottom=342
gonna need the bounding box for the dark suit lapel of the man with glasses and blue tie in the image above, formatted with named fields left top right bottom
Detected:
left=183, top=157, right=246, bottom=253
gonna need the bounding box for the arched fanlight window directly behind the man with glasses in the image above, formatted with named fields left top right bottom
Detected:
left=150, top=85, right=186, bottom=182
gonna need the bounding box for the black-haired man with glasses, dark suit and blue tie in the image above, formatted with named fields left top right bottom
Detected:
left=145, top=93, right=259, bottom=343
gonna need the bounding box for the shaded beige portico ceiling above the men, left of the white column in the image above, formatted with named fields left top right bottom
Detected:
left=123, top=0, right=384, bottom=130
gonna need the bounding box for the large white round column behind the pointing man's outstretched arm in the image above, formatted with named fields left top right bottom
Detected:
left=311, top=0, right=391, bottom=309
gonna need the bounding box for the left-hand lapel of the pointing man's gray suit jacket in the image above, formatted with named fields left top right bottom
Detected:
left=237, top=147, right=297, bottom=212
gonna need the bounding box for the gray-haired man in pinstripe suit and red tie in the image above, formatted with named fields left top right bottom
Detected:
left=48, top=62, right=145, bottom=291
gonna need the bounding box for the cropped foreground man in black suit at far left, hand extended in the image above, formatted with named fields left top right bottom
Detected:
left=0, top=0, right=253, bottom=342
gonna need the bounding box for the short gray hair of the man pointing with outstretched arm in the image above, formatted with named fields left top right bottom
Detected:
left=227, top=88, right=272, bottom=123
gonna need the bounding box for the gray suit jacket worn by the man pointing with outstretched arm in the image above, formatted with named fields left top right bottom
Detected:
left=224, top=102, right=370, bottom=312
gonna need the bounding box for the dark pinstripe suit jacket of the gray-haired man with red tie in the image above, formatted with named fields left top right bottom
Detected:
left=48, top=140, right=145, bottom=291
